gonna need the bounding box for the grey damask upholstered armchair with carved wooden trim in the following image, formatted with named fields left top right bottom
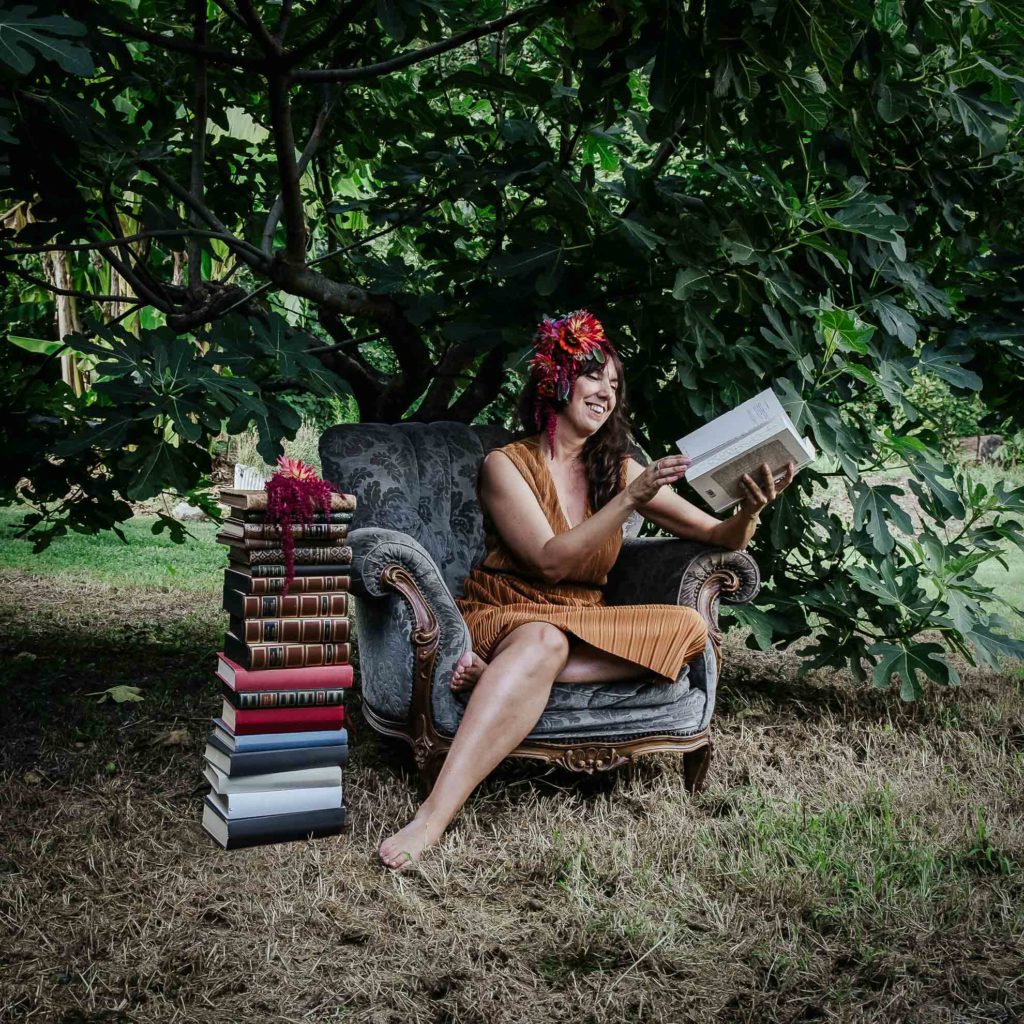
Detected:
left=319, top=422, right=760, bottom=792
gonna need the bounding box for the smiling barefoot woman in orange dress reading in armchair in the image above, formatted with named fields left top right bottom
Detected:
left=380, top=310, right=795, bottom=870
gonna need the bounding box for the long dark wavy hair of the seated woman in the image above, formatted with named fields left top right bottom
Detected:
left=513, top=348, right=633, bottom=512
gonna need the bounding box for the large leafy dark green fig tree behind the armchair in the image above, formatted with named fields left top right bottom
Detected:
left=0, top=0, right=1024, bottom=697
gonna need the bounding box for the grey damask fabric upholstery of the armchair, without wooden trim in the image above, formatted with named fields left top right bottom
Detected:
left=321, top=422, right=757, bottom=740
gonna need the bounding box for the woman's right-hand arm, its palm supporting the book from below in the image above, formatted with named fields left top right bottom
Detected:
left=626, top=458, right=795, bottom=551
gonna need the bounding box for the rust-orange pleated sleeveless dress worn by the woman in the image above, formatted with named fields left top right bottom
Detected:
left=456, top=435, right=708, bottom=683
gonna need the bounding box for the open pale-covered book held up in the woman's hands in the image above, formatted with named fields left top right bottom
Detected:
left=676, top=388, right=816, bottom=512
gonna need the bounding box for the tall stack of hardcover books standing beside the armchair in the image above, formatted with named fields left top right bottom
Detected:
left=203, top=488, right=355, bottom=849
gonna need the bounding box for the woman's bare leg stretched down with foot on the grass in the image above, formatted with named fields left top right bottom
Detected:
left=380, top=622, right=569, bottom=868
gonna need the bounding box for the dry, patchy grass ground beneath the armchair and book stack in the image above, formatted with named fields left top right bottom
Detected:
left=0, top=573, right=1024, bottom=1024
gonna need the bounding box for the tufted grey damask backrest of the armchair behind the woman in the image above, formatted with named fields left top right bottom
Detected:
left=319, top=421, right=512, bottom=596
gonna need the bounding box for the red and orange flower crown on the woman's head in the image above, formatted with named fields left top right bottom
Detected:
left=527, top=309, right=614, bottom=454
